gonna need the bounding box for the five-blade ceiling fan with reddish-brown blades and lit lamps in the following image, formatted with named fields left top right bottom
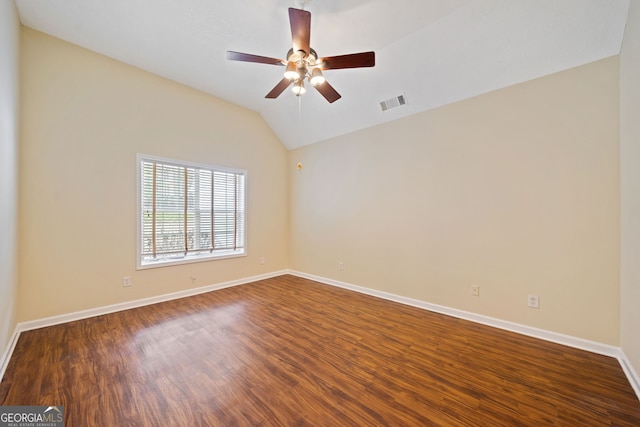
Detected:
left=227, top=7, right=376, bottom=103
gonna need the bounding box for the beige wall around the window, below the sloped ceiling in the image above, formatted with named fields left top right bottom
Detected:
left=19, top=28, right=288, bottom=321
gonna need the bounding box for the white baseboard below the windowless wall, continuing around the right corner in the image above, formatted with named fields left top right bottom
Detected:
left=288, top=270, right=640, bottom=400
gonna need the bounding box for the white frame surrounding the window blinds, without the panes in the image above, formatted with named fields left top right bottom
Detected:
left=136, top=153, right=249, bottom=270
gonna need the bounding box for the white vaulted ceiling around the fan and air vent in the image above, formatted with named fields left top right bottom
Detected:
left=15, top=0, right=629, bottom=149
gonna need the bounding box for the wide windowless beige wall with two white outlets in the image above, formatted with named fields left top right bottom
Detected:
left=289, top=58, right=620, bottom=345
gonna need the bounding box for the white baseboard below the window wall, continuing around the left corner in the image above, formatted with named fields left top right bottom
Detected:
left=0, top=270, right=287, bottom=381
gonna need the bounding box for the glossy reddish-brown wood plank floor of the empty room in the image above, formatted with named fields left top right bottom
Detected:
left=0, top=276, right=640, bottom=427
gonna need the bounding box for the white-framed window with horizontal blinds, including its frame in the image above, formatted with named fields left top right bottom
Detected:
left=138, top=155, right=247, bottom=268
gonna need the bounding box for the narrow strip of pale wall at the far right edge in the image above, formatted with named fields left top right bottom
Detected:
left=620, top=1, right=640, bottom=375
